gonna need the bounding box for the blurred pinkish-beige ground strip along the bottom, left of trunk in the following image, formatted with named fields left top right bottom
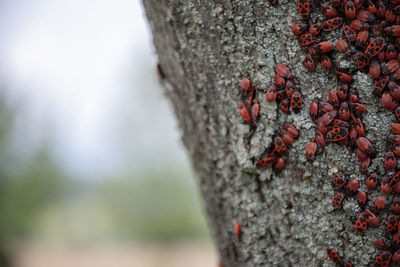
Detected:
left=15, top=243, right=217, bottom=267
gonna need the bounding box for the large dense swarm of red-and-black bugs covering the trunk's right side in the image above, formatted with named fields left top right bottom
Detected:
left=292, top=0, right=400, bottom=266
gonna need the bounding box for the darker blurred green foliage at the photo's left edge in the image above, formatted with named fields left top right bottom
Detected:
left=0, top=99, right=65, bottom=244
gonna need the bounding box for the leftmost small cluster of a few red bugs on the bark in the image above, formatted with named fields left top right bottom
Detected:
left=238, top=78, right=260, bottom=123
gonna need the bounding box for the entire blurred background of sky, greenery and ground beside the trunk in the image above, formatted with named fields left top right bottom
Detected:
left=0, top=0, right=217, bottom=267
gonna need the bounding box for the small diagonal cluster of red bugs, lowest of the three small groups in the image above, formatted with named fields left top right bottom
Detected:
left=255, top=122, right=299, bottom=171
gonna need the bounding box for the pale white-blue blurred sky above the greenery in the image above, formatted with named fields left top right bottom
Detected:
left=0, top=0, right=185, bottom=177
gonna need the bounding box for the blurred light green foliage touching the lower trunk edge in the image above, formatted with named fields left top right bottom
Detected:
left=99, top=164, right=207, bottom=242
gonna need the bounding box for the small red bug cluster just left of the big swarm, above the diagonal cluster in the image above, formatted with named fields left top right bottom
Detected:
left=265, top=64, right=303, bottom=113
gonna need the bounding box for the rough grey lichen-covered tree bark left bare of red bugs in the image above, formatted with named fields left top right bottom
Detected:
left=143, top=0, right=393, bottom=266
